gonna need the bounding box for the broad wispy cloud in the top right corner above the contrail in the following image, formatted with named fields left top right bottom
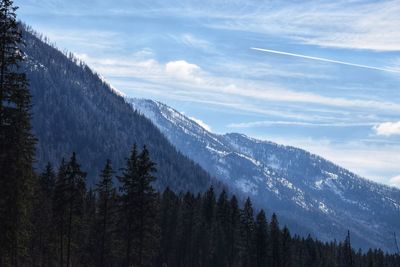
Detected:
left=205, top=0, right=400, bottom=51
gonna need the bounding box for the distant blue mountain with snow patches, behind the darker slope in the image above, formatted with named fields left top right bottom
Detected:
left=128, top=99, right=400, bottom=251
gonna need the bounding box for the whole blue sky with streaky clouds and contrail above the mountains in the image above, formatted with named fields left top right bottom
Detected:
left=14, top=0, right=400, bottom=187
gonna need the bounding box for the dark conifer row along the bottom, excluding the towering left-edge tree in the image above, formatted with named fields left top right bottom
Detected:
left=28, top=152, right=400, bottom=267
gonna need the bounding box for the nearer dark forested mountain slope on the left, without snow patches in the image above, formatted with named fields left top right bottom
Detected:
left=21, top=27, right=219, bottom=192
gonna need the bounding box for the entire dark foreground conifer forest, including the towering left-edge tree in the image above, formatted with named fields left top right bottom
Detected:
left=0, top=0, right=400, bottom=267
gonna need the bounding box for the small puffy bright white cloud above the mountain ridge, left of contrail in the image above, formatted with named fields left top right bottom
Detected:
left=165, top=60, right=202, bottom=83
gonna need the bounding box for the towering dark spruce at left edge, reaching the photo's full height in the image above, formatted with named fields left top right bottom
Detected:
left=0, top=0, right=35, bottom=266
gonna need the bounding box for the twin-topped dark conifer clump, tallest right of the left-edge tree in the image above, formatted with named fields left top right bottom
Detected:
left=119, top=146, right=159, bottom=267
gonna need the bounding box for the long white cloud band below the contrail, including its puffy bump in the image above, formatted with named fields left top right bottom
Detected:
left=77, top=52, right=400, bottom=116
